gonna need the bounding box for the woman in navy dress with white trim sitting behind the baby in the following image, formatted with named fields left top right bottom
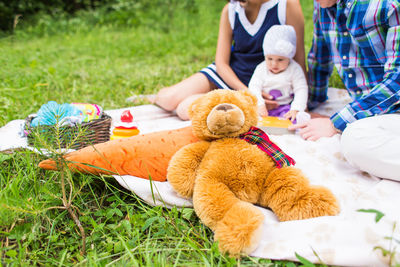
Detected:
left=154, top=0, right=305, bottom=120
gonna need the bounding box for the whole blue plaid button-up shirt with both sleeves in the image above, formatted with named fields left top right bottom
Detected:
left=308, top=0, right=400, bottom=130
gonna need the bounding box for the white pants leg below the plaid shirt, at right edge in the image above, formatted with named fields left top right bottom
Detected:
left=341, top=113, right=400, bottom=181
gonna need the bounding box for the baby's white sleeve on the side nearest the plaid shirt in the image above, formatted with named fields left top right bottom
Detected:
left=290, top=62, right=308, bottom=111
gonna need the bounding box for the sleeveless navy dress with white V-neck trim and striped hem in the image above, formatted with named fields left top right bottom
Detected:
left=200, top=0, right=286, bottom=89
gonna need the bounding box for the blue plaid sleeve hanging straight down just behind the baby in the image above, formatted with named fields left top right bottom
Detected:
left=307, top=3, right=333, bottom=109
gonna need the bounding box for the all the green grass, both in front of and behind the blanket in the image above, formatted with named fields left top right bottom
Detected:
left=0, top=0, right=344, bottom=266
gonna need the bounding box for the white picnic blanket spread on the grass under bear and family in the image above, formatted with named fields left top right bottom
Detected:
left=0, top=88, right=400, bottom=266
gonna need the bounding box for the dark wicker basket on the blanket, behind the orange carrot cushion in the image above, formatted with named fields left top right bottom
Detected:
left=25, top=113, right=111, bottom=149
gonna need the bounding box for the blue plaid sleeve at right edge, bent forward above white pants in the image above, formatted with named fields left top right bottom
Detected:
left=331, top=1, right=400, bottom=130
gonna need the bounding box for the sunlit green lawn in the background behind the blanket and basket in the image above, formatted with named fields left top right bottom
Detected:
left=0, top=1, right=220, bottom=125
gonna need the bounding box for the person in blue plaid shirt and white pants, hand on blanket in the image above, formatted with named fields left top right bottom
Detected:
left=292, top=0, right=400, bottom=180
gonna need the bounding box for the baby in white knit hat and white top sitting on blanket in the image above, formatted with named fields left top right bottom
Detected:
left=249, top=25, right=308, bottom=121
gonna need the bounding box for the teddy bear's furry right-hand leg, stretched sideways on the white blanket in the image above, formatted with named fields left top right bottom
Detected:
left=260, top=167, right=339, bottom=221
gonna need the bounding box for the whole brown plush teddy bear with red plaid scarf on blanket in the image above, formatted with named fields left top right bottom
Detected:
left=167, top=90, right=339, bottom=256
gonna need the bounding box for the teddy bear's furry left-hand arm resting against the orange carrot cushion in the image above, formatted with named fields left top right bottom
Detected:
left=167, top=141, right=210, bottom=198
